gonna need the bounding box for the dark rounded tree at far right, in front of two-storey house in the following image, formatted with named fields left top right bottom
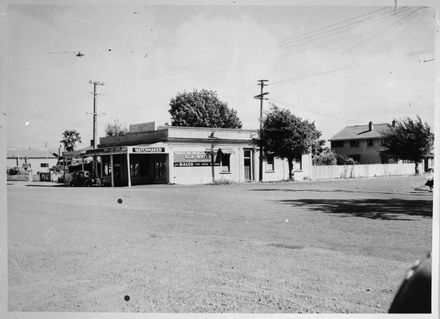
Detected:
left=380, top=116, right=434, bottom=174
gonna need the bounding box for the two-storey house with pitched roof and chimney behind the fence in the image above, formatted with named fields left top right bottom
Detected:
left=329, top=122, right=392, bottom=164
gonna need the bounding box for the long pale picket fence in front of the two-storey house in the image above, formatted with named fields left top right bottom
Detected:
left=310, top=163, right=416, bottom=179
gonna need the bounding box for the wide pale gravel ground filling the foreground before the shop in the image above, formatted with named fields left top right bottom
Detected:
left=7, top=176, right=432, bottom=313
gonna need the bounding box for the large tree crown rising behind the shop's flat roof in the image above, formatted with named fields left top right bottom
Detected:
left=169, top=90, right=242, bottom=128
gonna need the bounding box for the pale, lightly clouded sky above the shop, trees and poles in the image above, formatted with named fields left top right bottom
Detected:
left=3, top=1, right=436, bottom=149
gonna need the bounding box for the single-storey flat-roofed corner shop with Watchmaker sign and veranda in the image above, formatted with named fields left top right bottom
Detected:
left=82, top=125, right=311, bottom=186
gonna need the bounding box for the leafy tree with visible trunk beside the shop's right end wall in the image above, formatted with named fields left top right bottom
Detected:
left=254, top=105, right=321, bottom=179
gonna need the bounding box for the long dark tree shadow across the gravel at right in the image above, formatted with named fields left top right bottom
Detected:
left=281, top=198, right=432, bottom=220
